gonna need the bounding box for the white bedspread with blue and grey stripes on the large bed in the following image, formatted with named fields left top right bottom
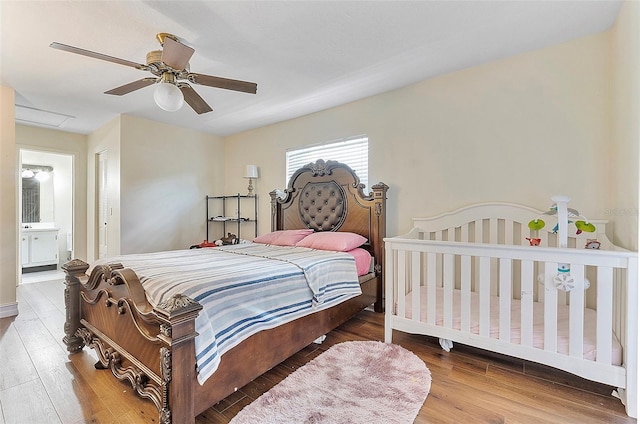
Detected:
left=94, top=243, right=361, bottom=384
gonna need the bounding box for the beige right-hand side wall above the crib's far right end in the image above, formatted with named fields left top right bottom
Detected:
left=607, top=1, right=640, bottom=250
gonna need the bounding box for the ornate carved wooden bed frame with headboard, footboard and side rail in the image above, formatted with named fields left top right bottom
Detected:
left=62, top=160, right=388, bottom=424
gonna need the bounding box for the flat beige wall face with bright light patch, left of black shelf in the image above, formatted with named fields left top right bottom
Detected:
left=120, top=115, right=224, bottom=254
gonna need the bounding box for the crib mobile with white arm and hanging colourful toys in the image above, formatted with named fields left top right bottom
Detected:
left=526, top=196, right=600, bottom=292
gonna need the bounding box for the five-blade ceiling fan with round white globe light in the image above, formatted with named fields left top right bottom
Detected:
left=49, top=32, right=258, bottom=114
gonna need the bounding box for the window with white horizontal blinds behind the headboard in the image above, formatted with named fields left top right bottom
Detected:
left=285, top=136, right=369, bottom=188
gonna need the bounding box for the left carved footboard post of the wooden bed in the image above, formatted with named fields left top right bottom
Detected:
left=62, top=259, right=89, bottom=353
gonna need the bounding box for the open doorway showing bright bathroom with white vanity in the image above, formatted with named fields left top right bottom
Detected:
left=18, top=148, right=74, bottom=284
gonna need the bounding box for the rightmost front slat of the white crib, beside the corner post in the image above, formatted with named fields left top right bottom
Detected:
left=596, top=266, right=613, bottom=364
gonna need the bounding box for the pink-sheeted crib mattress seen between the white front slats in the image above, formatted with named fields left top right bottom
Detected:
left=404, top=286, right=622, bottom=365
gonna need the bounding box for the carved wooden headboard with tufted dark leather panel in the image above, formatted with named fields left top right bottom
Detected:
left=269, top=160, right=389, bottom=274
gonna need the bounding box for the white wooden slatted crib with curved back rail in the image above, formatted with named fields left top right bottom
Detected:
left=384, top=203, right=638, bottom=417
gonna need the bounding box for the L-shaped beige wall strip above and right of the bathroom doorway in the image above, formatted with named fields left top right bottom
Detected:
left=16, top=125, right=88, bottom=260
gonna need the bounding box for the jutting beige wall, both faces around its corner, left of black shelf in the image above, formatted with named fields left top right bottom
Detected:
left=87, top=115, right=224, bottom=261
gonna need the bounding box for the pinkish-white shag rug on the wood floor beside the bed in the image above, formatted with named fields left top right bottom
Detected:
left=231, top=341, right=431, bottom=424
